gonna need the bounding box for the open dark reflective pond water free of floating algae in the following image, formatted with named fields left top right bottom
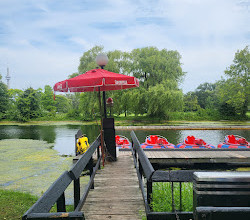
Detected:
left=0, top=125, right=250, bottom=155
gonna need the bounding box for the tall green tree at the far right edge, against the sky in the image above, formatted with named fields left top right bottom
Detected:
left=217, top=46, right=250, bottom=117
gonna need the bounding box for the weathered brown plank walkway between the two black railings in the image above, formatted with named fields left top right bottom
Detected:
left=82, top=152, right=145, bottom=220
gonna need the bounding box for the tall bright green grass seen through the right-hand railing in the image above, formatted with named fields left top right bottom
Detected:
left=151, top=183, right=193, bottom=212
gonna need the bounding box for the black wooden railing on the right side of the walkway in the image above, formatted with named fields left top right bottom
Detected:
left=131, top=131, right=194, bottom=220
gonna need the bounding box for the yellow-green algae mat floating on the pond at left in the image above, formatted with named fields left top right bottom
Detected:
left=0, top=139, right=85, bottom=203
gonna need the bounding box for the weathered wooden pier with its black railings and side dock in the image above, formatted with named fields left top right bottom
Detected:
left=22, top=132, right=250, bottom=220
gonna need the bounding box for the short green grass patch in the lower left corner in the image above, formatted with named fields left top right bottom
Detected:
left=0, top=189, right=74, bottom=220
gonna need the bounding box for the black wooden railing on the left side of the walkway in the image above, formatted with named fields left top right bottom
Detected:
left=22, top=136, right=101, bottom=220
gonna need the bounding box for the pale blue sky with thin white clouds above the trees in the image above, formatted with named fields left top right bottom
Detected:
left=0, top=0, right=250, bottom=93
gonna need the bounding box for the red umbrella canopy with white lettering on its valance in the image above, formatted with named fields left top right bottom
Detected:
left=54, top=69, right=139, bottom=92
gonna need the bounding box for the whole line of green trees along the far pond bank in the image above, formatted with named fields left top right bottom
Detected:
left=0, top=46, right=250, bottom=121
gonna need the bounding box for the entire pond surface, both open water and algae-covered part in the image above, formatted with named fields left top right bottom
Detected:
left=0, top=125, right=250, bottom=204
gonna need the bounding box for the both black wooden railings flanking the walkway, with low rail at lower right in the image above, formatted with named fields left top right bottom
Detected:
left=22, top=131, right=250, bottom=220
